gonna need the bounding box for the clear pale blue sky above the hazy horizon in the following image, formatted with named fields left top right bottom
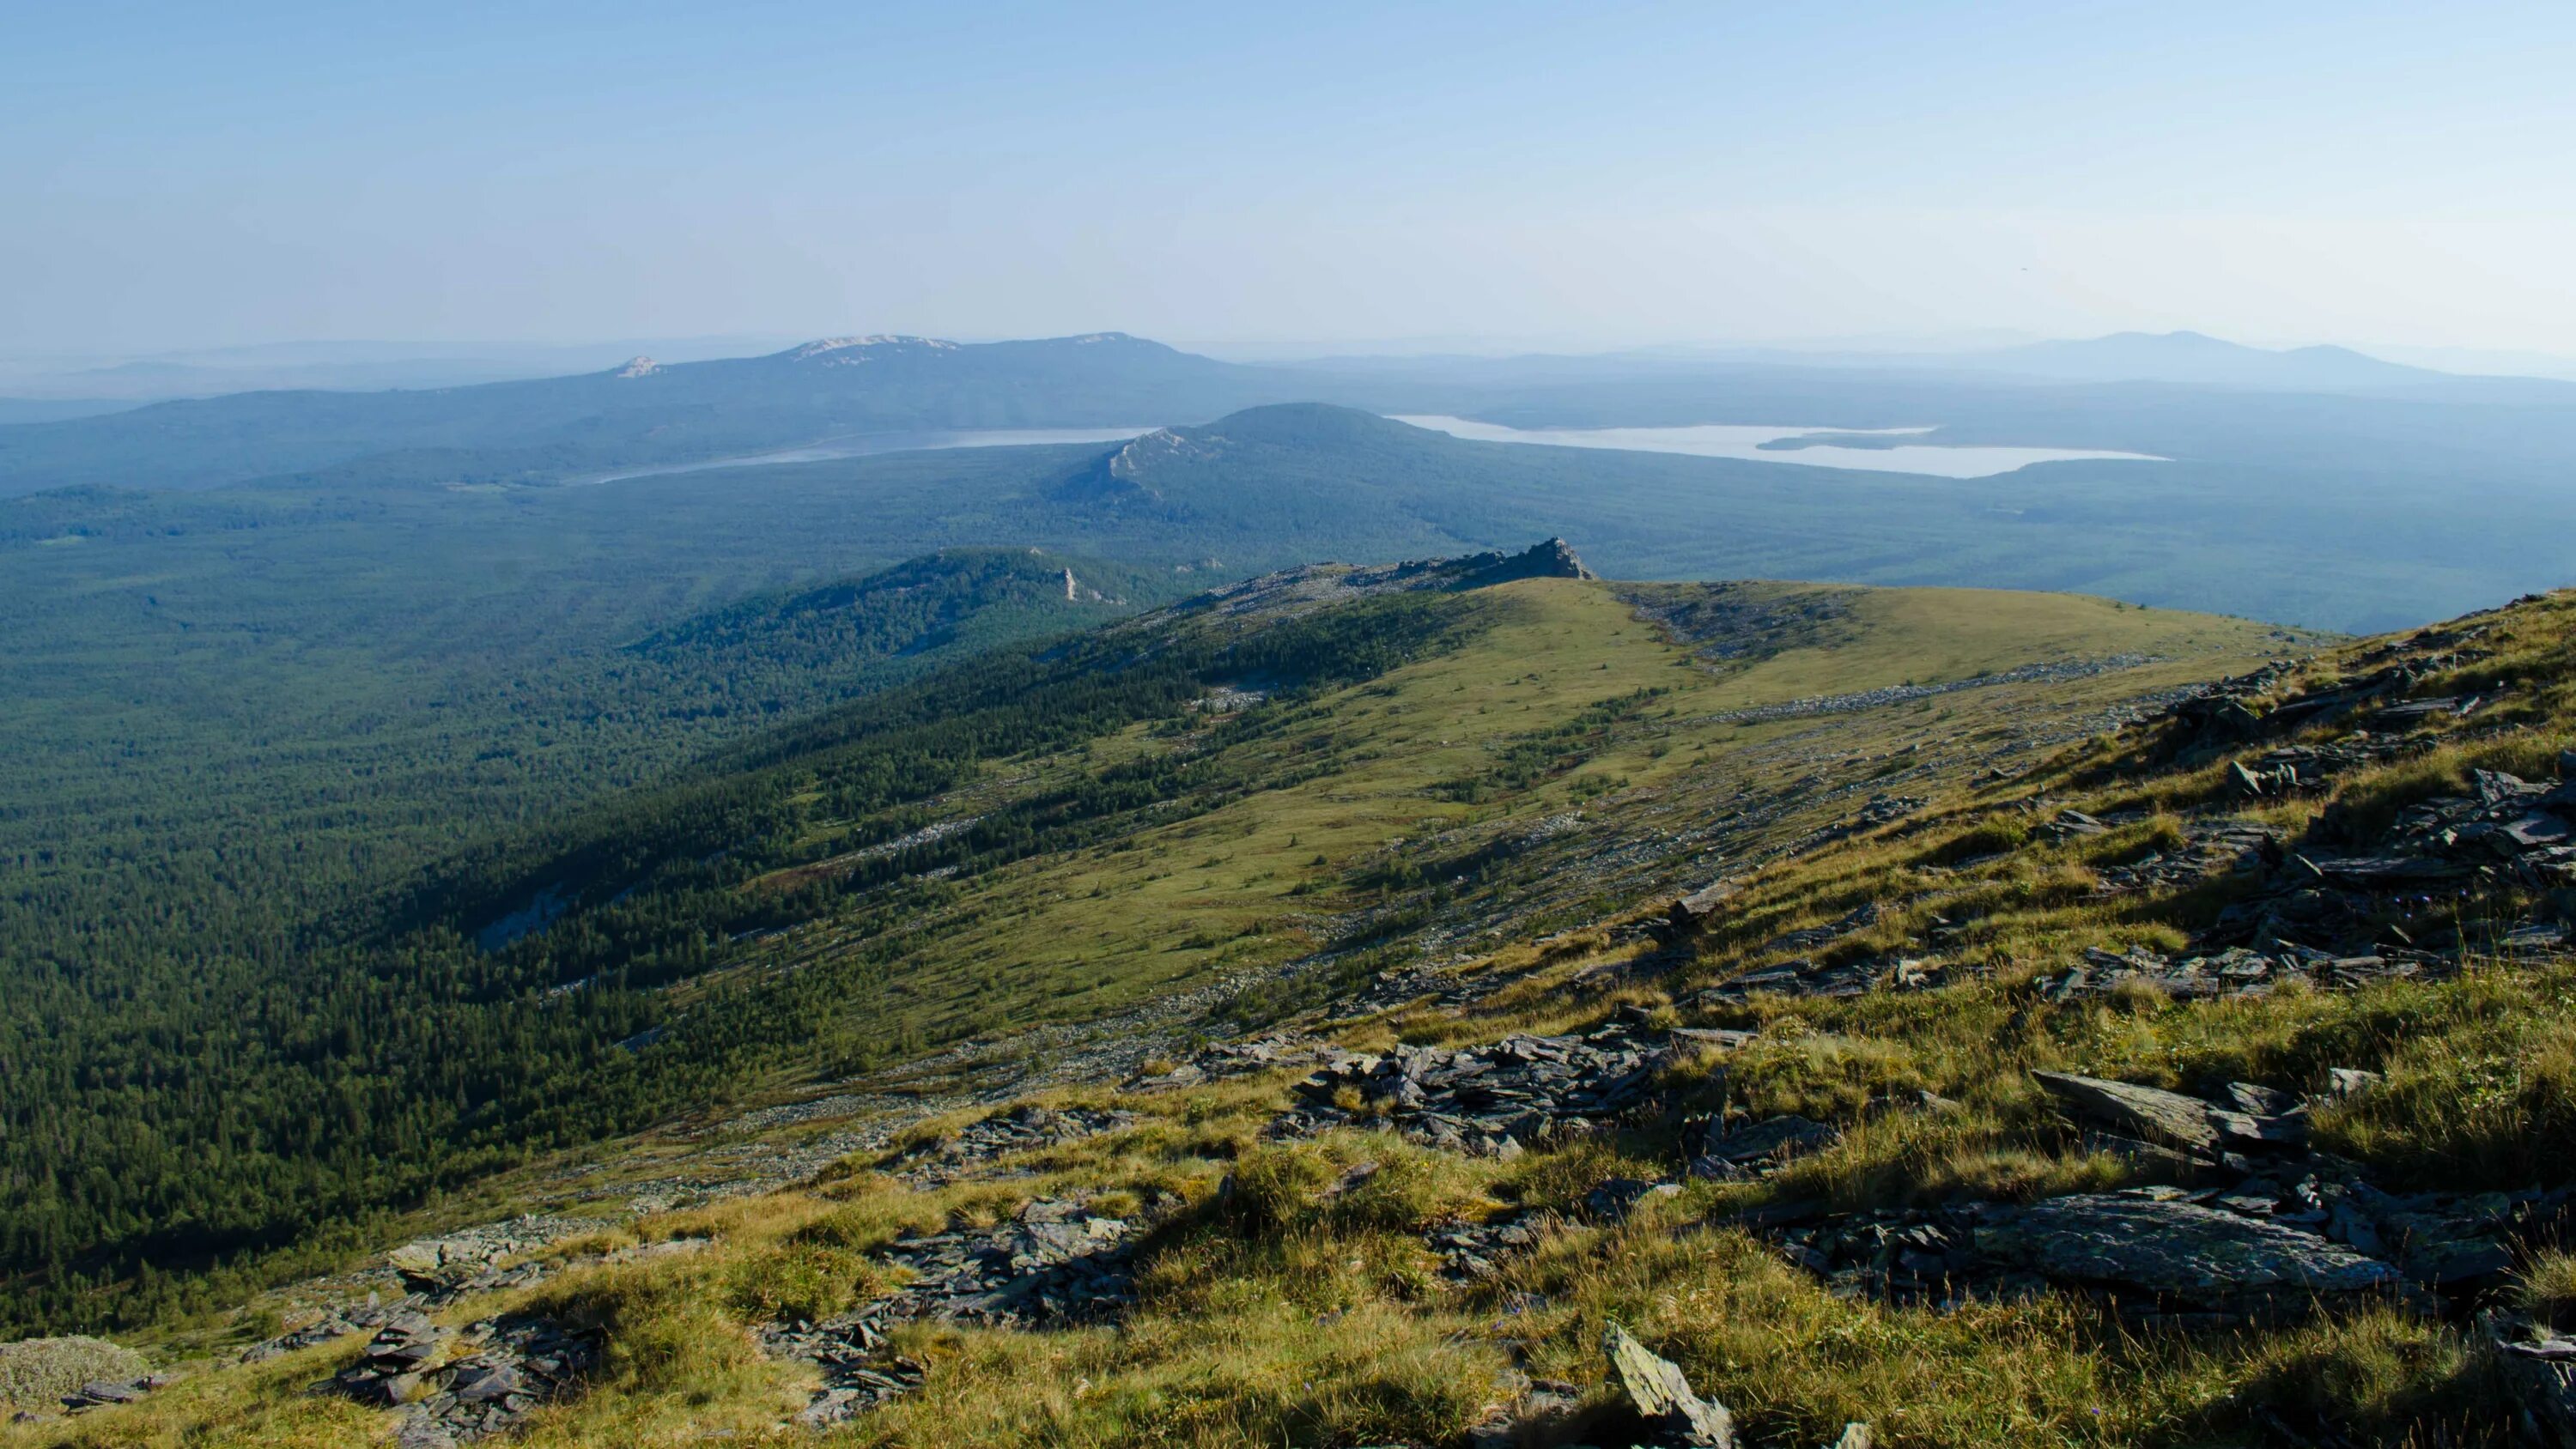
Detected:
left=0, top=0, right=2576, bottom=353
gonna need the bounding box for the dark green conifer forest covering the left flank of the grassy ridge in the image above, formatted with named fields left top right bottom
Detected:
left=0, top=574, right=1473, bottom=1328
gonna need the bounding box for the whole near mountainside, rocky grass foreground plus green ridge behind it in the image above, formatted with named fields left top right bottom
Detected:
left=8, top=546, right=2576, bottom=1446
